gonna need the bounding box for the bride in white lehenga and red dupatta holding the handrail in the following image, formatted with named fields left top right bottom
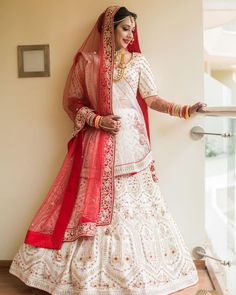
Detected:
left=10, top=6, right=203, bottom=295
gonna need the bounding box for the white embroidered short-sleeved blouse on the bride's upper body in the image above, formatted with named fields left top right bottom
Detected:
left=112, top=53, right=158, bottom=176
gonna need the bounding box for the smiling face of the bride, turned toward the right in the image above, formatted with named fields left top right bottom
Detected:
left=115, top=16, right=135, bottom=50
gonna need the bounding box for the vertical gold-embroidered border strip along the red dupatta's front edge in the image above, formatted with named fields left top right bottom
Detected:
left=97, top=6, right=119, bottom=225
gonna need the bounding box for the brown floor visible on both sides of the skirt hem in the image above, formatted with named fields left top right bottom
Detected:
left=0, top=267, right=216, bottom=295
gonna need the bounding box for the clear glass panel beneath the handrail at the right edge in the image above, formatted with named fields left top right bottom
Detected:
left=205, top=117, right=236, bottom=295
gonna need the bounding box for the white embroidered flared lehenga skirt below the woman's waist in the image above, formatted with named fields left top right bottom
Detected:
left=10, top=167, right=198, bottom=295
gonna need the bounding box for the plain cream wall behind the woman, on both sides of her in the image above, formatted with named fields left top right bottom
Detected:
left=0, top=0, right=204, bottom=259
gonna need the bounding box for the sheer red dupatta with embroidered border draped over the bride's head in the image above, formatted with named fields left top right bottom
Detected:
left=25, top=6, right=149, bottom=249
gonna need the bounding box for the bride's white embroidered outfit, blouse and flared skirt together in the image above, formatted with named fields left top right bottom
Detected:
left=10, top=53, right=198, bottom=295
